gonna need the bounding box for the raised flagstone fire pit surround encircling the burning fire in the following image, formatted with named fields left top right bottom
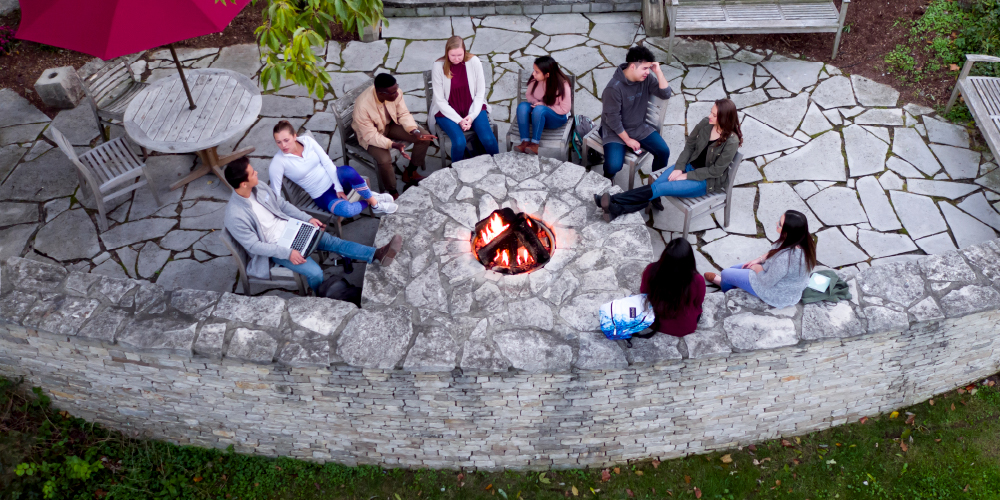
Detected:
left=360, top=153, right=654, bottom=371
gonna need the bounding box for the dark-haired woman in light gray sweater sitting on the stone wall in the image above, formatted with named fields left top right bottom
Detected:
left=705, top=210, right=816, bottom=308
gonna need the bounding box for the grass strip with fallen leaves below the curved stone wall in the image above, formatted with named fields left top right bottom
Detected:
left=0, top=379, right=1000, bottom=500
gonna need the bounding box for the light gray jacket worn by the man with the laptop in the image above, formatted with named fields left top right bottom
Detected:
left=225, top=183, right=311, bottom=279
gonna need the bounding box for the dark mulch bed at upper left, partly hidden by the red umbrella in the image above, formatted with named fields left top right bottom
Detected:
left=0, top=6, right=358, bottom=118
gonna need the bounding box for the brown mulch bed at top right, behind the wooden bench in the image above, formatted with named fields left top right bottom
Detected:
left=697, top=0, right=958, bottom=107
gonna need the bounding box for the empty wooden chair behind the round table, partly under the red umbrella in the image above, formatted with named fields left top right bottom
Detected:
left=83, top=57, right=149, bottom=143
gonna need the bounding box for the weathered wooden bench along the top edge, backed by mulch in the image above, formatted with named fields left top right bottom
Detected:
left=643, top=0, right=851, bottom=59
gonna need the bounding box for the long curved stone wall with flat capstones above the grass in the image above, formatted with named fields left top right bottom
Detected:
left=0, top=235, right=1000, bottom=469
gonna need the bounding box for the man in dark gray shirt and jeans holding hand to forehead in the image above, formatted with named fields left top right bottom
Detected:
left=601, top=46, right=671, bottom=181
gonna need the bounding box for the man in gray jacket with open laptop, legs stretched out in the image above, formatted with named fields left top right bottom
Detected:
left=225, top=157, right=403, bottom=290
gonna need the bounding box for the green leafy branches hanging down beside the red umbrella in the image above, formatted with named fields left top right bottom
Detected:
left=215, top=0, right=388, bottom=99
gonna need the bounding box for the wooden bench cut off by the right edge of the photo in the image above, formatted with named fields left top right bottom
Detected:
left=944, top=54, right=1000, bottom=165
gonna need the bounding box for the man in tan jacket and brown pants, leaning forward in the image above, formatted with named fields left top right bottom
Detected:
left=352, top=73, right=435, bottom=198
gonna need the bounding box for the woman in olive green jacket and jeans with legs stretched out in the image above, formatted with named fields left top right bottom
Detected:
left=594, top=99, right=743, bottom=222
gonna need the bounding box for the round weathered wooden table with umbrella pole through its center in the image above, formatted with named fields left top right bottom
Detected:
left=124, top=68, right=261, bottom=189
